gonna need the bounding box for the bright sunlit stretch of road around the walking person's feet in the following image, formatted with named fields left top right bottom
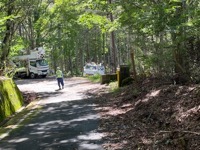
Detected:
left=17, top=79, right=95, bottom=104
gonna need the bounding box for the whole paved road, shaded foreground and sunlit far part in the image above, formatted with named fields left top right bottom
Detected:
left=0, top=78, right=103, bottom=150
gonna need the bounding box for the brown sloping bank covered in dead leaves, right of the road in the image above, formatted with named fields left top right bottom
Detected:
left=88, top=78, right=200, bottom=150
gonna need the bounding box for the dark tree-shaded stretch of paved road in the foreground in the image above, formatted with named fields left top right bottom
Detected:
left=0, top=99, right=103, bottom=150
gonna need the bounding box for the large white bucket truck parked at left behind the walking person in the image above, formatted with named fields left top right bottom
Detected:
left=12, top=47, right=49, bottom=78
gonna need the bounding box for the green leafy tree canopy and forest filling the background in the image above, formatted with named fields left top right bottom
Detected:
left=0, top=0, right=200, bottom=82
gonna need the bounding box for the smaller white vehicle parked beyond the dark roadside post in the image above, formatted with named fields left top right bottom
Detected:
left=83, top=63, right=105, bottom=75
